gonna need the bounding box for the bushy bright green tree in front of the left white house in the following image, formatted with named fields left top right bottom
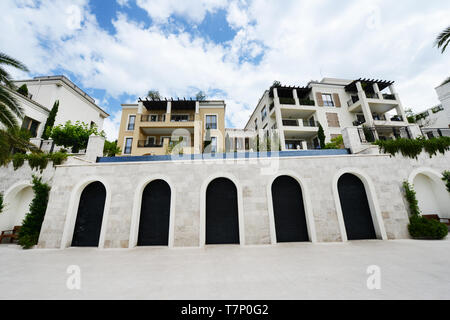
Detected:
left=49, top=121, right=105, bottom=153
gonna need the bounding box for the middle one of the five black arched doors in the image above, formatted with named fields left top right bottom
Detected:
left=206, top=178, right=239, bottom=244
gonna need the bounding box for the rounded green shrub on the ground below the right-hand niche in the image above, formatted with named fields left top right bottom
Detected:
left=408, top=215, right=448, bottom=240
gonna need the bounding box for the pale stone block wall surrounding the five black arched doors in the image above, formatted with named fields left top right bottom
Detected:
left=39, top=153, right=450, bottom=248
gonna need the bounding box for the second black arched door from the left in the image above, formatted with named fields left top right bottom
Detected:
left=137, top=180, right=171, bottom=246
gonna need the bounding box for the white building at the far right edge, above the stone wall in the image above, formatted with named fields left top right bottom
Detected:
left=416, top=82, right=450, bottom=134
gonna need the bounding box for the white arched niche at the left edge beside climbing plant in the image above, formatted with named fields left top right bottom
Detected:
left=0, top=185, right=34, bottom=232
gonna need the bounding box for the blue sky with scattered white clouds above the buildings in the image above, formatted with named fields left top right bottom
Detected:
left=0, top=0, right=450, bottom=139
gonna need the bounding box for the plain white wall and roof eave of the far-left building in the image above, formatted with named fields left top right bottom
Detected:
left=14, top=76, right=109, bottom=130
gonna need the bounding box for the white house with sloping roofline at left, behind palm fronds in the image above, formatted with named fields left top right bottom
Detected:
left=14, top=76, right=109, bottom=132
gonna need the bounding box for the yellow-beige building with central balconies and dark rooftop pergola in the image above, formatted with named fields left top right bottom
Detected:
left=118, top=99, right=225, bottom=156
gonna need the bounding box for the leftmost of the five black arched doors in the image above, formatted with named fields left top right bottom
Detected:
left=72, top=181, right=106, bottom=247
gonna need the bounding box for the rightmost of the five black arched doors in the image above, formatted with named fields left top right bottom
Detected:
left=338, top=173, right=377, bottom=240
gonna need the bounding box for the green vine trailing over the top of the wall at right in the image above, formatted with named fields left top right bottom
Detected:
left=374, top=137, right=450, bottom=159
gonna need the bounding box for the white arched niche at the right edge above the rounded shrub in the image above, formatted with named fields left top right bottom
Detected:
left=413, top=173, right=450, bottom=218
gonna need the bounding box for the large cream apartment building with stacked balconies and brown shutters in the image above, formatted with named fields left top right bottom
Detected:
left=245, top=78, right=407, bottom=151
